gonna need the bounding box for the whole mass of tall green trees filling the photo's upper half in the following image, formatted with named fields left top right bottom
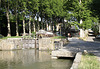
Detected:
left=0, top=0, right=100, bottom=36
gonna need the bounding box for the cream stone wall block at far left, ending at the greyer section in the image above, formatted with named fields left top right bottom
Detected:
left=0, top=38, right=22, bottom=50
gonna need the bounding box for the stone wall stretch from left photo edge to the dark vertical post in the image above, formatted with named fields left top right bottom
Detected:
left=0, top=38, right=38, bottom=50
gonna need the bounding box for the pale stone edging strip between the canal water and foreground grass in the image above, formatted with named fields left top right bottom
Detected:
left=70, top=52, right=82, bottom=69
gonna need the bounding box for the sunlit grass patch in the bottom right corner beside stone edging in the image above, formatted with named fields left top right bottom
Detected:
left=78, top=54, right=100, bottom=69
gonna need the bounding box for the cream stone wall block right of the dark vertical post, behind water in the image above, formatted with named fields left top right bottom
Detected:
left=39, top=38, right=64, bottom=50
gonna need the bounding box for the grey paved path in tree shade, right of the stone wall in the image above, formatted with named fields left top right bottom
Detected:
left=63, top=37, right=100, bottom=60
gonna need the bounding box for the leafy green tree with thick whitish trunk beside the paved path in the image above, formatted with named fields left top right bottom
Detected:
left=70, top=0, right=92, bottom=37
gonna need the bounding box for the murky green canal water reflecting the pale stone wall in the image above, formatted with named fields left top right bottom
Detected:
left=0, top=49, right=72, bottom=69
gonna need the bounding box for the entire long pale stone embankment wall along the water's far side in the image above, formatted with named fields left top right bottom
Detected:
left=0, top=38, right=66, bottom=50
